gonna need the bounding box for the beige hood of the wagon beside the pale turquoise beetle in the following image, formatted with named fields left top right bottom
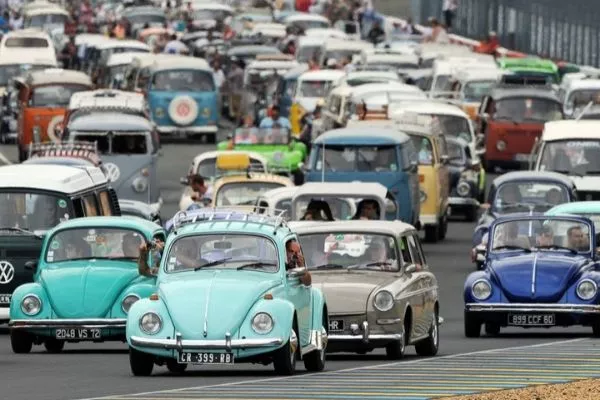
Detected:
left=311, top=271, right=396, bottom=314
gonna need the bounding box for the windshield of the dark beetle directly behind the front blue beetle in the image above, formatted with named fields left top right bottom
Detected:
left=492, top=181, right=570, bottom=214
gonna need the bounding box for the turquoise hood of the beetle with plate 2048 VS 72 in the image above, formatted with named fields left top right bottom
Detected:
left=40, top=261, right=140, bottom=318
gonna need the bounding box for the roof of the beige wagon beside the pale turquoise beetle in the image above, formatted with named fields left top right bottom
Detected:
left=288, top=220, right=416, bottom=236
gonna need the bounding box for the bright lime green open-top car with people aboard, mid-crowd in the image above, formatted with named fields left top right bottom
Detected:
left=217, top=128, right=307, bottom=173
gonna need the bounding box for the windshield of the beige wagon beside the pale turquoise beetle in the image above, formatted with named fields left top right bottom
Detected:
left=299, top=232, right=400, bottom=272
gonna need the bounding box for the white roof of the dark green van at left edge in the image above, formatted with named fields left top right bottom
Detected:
left=0, top=164, right=107, bottom=194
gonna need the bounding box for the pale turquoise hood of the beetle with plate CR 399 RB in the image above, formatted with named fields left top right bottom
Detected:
left=159, top=270, right=281, bottom=339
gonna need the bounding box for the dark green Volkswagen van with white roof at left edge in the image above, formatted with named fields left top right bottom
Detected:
left=0, top=164, right=121, bottom=321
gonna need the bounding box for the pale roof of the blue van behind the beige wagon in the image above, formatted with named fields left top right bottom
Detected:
left=313, top=126, right=410, bottom=145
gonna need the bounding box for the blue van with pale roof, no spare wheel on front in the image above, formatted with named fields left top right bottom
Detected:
left=305, top=126, right=421, bottom=226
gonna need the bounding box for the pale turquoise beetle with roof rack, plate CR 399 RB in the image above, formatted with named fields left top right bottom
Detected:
left=127, top=209, right=329, bottom=376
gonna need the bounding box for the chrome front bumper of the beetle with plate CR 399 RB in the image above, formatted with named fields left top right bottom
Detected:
left=131, top=333, right=283, bottom=351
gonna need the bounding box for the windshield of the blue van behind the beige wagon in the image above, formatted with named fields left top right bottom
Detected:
left=314, top=145, right=400, bottom=172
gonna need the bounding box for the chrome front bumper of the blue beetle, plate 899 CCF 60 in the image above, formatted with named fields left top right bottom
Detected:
left=465, top=303, right=600, bottom=314
